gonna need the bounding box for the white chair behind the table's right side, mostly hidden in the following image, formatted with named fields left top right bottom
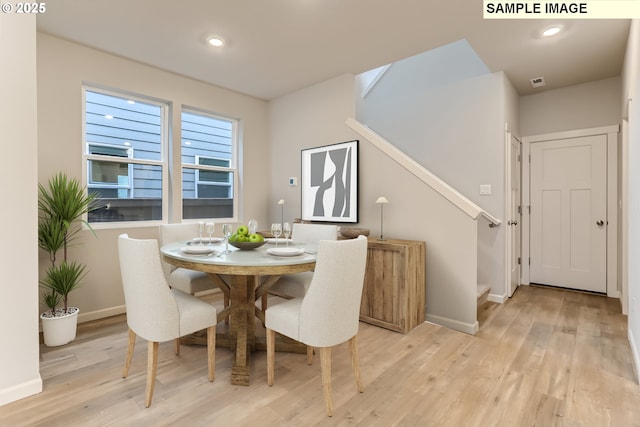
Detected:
left=262, top=222, right=338, bottom=310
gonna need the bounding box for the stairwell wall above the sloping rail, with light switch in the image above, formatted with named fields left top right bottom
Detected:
left=357, top=41, right=510, bottom=301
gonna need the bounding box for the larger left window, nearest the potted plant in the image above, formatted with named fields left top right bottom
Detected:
left=84, top=88, right=168, bottom=223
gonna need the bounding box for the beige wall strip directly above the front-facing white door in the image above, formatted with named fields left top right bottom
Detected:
left=520, top=77, right=621, bottom=136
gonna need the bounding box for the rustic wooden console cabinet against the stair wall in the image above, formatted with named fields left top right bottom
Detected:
left=360, top=237, right=426, bottom=333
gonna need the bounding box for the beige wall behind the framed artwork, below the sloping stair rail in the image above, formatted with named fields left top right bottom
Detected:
left=270, top=75, right=478, bottom=332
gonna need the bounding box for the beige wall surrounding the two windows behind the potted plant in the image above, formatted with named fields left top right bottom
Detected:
left=38, top=33, right=271, bottom=321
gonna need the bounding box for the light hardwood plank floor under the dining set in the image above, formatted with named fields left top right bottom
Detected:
left=0, top=286, right=640, bottom=427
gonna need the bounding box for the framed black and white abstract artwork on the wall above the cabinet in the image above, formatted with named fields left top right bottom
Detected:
left=301, top=140, right=358, bottom=222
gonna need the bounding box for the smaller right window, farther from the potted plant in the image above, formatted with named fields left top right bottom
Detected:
left=182, top=110, right=238, bottom=219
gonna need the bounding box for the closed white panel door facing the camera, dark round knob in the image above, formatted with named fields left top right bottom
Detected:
left=531, top=135, right=607, bottom=293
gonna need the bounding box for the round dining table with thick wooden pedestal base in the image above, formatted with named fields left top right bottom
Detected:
left=160, top=241, right=317, bottom=385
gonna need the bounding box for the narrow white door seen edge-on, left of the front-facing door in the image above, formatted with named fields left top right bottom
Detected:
left=507, top=135, right=522, bottom=297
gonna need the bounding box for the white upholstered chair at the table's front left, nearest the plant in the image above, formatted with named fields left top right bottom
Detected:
left=118, top=234, right=217, bottom=408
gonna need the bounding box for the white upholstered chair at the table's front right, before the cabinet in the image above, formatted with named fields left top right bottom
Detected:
left=265, top=236, right=367, bottom=416
